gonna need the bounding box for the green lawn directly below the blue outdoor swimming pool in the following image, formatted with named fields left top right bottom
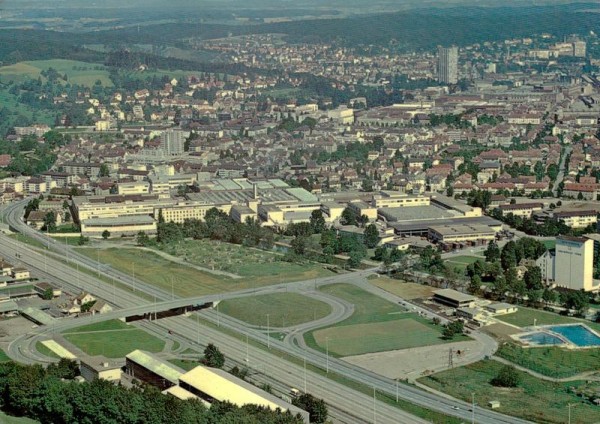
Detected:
left=496, top=343, right=600, bottom=378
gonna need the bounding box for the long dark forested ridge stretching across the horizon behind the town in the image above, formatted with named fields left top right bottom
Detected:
left=0, top=4, right=600, bottom=64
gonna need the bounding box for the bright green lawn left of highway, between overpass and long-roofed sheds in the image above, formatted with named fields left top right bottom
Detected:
left=63, top=320, right=165, bottom=358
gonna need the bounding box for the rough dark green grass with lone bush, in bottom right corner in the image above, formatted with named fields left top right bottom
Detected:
left=419, top=360, right=600, bottom=423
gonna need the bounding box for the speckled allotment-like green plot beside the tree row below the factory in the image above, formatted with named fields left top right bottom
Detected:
left=158, top=240, right=331, bottom=284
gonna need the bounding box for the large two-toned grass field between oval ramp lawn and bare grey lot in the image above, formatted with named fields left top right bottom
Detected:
left=305, top=284, right=460, bottom=356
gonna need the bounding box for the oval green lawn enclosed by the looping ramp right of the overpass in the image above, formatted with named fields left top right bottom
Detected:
left=219, top=293, right=331, bottom=327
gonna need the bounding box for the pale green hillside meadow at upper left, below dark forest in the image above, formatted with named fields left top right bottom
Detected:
left=0, top=59, right=113, bottom=87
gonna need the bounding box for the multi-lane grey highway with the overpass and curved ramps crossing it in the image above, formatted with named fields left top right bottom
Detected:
left=0, top=202, right=526, bottom=423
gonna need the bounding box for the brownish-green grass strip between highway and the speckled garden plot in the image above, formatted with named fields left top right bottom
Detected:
left=77, top=248, right=330, bottom=297
